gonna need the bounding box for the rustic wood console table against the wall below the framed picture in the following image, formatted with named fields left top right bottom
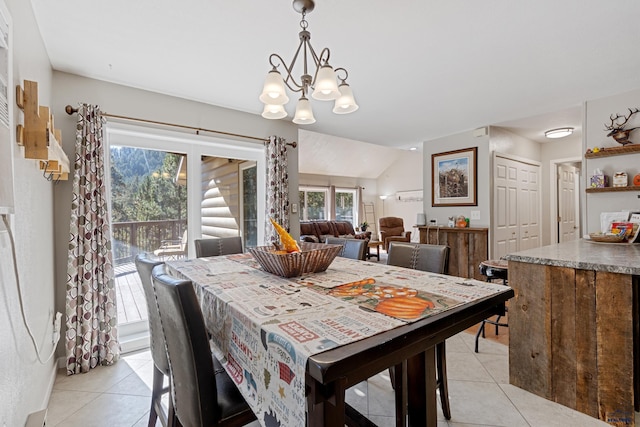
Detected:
left=417, top=225, right=489, bottom=280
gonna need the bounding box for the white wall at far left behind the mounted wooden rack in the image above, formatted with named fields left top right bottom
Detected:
left=0, top=0, right=55, bottom=426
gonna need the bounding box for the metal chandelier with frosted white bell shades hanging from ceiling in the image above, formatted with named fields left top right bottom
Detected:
left=260, top=0, right=358, bottom=125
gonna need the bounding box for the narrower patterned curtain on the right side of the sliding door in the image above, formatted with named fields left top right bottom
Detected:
left=264, top=136, right=289, bottom=245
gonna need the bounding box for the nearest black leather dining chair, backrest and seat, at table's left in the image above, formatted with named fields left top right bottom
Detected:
left=151, top=265, right=256, bottom=427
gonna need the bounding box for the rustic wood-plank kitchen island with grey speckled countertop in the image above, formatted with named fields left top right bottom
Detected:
left=505, top=239, right=640, bottom=426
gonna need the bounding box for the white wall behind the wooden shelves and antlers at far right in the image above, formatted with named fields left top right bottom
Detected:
left=582, top=89, right=640, bottom=233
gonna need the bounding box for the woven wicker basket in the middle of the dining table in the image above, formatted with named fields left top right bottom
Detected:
left=249, top=242, right=342, bottom=277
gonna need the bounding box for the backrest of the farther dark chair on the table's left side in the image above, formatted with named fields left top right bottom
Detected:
left=135, top=253, right=169, bottom=376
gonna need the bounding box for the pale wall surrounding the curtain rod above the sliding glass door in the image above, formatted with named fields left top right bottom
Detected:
left=52, top=71, right=300, bottom=351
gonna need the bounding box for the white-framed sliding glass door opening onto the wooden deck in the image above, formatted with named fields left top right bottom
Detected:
left=107, top=124, right=266, bottom=351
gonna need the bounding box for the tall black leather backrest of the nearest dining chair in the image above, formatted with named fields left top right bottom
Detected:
left=151, top=265, right=220, bottom=426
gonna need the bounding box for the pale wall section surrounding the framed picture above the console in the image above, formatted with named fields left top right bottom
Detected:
left=422, top=131, right=491, bottom=227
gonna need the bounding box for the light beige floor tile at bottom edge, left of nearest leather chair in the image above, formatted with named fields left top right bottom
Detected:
left=48, top=394, right=149, bottom=427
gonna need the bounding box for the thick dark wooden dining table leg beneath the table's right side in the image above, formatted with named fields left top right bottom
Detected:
left=407, top=347, right=438, bottom=427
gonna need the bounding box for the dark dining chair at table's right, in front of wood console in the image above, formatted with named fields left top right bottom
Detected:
left=387, top=242, right=451, bottom=420
